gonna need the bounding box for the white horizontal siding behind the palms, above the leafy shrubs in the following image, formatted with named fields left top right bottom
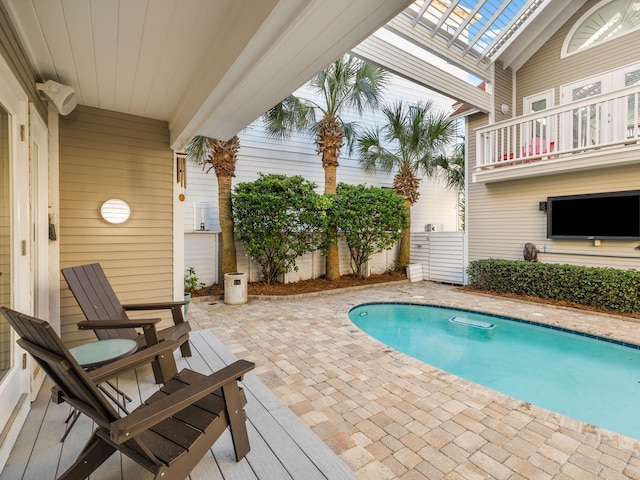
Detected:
left=183, top=72, right=457, bottom=235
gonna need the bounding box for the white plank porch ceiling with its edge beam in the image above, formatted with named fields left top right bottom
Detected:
left=1, top=0, right=412, bottom=149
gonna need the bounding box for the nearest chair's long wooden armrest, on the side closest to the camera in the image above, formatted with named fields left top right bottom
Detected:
left=110, top=360, right=255, bottom=444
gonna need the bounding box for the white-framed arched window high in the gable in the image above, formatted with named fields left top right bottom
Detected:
left=561, top=0, right=640, bottom=58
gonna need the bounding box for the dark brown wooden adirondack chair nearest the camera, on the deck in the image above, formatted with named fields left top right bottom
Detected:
left=0, top=307, right=255, bottom=480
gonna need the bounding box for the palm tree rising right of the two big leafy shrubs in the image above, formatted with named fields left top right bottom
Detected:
left=357, top=101, right=455, bottom=267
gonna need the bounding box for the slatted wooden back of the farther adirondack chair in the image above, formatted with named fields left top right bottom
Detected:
left=62, top=263, right=138, bottom=340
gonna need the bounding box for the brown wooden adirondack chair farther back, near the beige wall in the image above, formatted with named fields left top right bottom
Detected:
left=62, top=263, right=191, bottom=383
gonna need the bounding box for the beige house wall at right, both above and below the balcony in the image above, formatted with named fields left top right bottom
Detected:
left=466, top=0, right=640, bottom=269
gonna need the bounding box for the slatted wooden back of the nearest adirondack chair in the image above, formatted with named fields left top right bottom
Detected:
left=0, top=307, right=120, bottom=428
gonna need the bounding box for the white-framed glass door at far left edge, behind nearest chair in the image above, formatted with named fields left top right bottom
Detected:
left=0, top=56, right=33, bottom=468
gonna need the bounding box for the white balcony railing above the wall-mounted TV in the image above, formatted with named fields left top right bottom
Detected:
left=476, top=85, right=640, bottom=171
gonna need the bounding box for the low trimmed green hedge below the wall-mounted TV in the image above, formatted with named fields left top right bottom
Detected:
left=467, top=258, right=640, bottom=313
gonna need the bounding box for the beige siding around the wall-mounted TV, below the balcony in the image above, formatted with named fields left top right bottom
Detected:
left=468, top=166, right=640, bottom=269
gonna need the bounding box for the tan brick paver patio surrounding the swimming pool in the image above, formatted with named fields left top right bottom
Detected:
left=188, top=282, right=640, bottom=480
